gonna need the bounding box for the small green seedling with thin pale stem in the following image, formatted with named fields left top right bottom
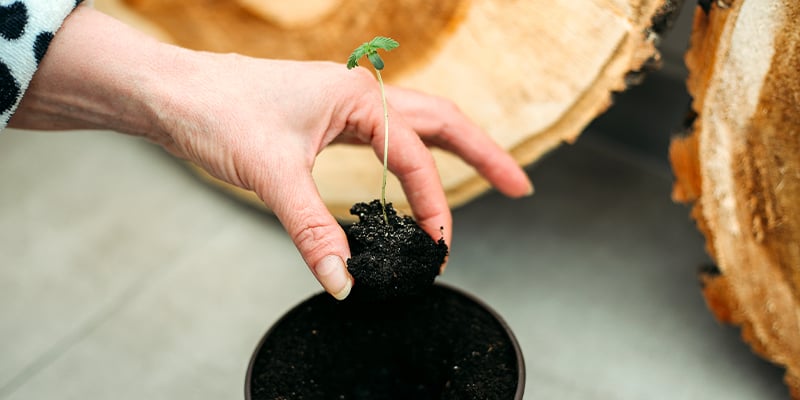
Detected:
left=347, top=36, right=400, bottom=225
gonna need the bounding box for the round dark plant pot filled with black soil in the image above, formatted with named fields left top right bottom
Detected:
left=245, top=283, right=525, bottom=400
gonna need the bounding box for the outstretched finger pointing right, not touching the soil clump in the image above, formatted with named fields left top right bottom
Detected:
left=387, top=87, right=533, bottom=198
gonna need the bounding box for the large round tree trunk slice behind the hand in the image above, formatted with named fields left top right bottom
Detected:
left=96, top=0, right=680, bottom=219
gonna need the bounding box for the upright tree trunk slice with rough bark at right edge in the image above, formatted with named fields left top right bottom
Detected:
left=670, top=0, right=800, bottom=399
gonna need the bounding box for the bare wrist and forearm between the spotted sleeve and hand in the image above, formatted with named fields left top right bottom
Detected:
left=9, top=7, right=169, bottom=142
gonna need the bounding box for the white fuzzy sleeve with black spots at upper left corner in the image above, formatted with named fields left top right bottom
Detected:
left=0, top=0, right=83, bottom=129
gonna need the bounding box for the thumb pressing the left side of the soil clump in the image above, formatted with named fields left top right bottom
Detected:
left=259, top=171, right=353, bottom=300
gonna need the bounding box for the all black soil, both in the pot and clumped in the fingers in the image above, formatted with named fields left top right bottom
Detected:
left=248, top=200, right=519, bottom=400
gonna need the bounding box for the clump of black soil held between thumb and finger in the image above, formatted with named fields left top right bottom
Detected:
left=346, top=200, right=447, bottom=301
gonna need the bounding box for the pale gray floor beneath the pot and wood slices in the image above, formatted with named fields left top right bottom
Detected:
left=0, top=124, right=788, bottom=400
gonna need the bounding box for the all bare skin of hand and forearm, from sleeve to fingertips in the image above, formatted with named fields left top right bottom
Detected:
left=9, top=6, right=533, bottom=299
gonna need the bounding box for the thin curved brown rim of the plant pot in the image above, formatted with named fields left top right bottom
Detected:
left=244, top=282, right=525, bottom=400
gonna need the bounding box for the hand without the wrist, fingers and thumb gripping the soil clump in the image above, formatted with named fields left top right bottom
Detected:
left=152, top=53, right=530, bottom=298
